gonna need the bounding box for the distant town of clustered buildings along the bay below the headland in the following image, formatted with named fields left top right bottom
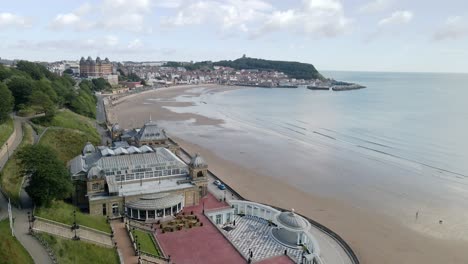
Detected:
left=0, top=57, right=316, bottom=89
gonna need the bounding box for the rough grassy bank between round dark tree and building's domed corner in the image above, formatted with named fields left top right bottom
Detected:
left=39, top=128, right=101, bottom=163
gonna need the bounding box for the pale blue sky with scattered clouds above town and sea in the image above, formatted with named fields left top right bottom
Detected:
left=0, top=0, right=468, bottom=72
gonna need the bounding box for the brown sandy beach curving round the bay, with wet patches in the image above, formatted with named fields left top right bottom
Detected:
left=108, top=85, right=468, bottom=264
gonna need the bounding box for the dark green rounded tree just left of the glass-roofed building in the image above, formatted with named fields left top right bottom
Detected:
left=18, top=145, right=73, bottom=207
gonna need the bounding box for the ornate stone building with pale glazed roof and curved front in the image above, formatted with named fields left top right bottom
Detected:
left=69, top=141, right=208, bottom=222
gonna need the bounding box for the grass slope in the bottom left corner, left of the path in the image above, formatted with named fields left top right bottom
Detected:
left=0, top=219, right=34, bottom=264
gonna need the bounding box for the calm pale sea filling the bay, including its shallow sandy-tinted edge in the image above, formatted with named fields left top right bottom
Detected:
left=161, top=72, right=468, bottom=239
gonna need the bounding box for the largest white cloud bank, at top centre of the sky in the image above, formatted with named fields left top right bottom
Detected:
left=162, top=0, right=351, bottom=37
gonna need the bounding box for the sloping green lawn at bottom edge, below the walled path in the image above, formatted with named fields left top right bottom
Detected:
left=37, top=233, right=119, bottom=264
